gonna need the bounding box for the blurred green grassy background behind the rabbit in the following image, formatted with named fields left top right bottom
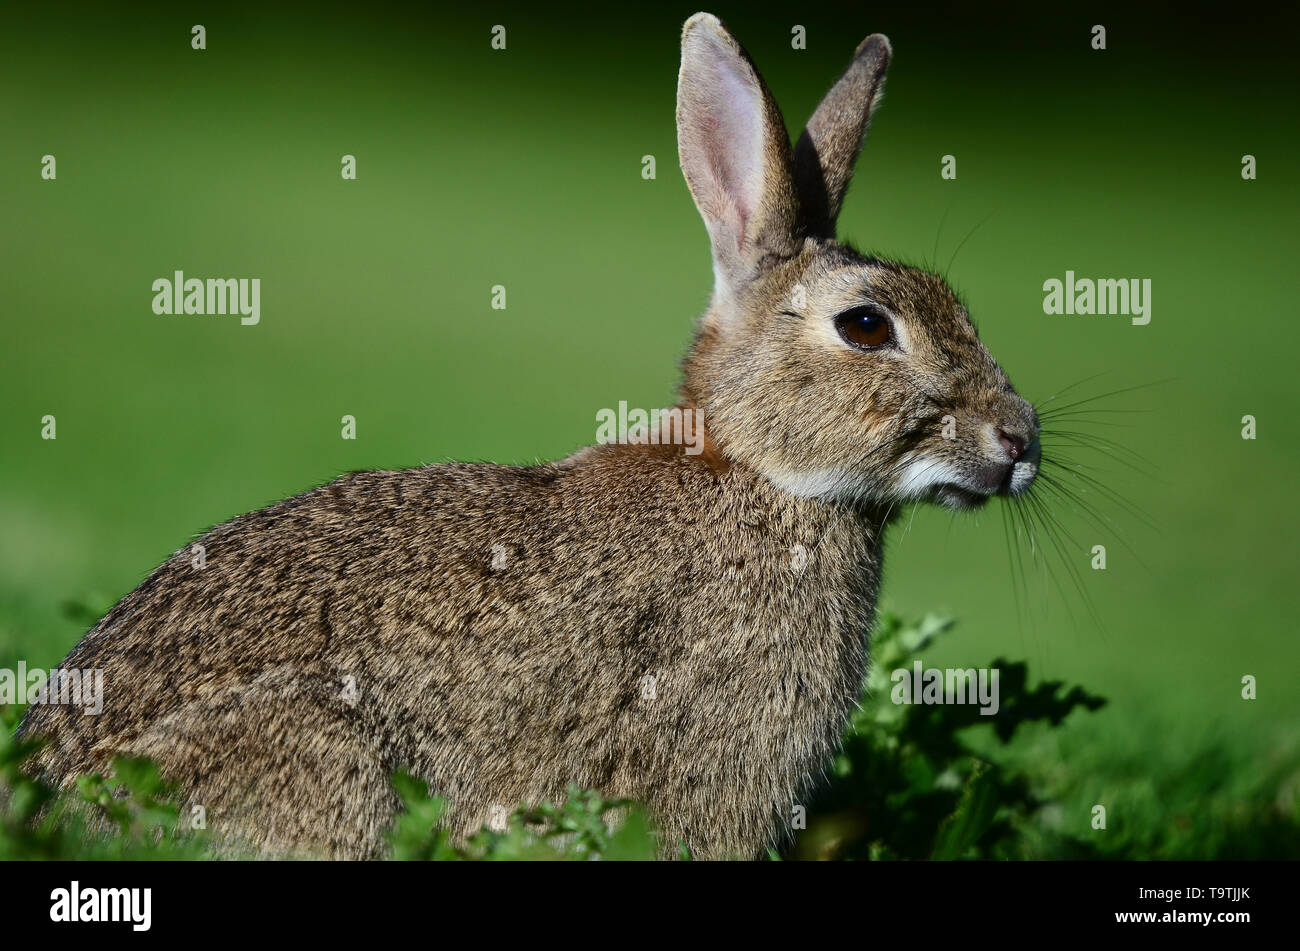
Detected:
left=0, top=4, right=1300, bottom=857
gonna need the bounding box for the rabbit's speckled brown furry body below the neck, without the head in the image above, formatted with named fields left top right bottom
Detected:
left=23, top=446, right=879, bottom=855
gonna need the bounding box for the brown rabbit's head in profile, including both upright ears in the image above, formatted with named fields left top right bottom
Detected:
left=677, top=13, right=1040, bottom=508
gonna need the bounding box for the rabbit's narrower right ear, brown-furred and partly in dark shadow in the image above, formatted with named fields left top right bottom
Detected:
left=794, top=34, right=892, bottom=238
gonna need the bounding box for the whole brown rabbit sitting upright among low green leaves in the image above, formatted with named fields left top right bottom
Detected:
left=21, top=13, right=1041, bottom=859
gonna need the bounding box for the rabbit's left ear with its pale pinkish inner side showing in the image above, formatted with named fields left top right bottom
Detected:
left=677, top=13, right=802, bottom=292
